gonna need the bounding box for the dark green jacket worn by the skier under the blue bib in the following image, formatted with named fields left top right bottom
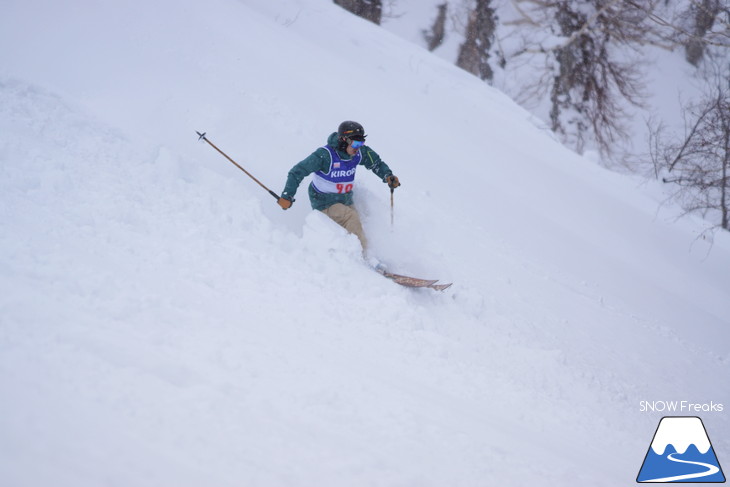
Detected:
left=281, top=132, right=393, bottom=210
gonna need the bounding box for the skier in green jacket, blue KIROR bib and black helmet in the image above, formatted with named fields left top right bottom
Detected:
left=278, top=120, right=400, bottom=253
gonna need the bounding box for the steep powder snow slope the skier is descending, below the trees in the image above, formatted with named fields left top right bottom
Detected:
left=0, top=0, right=730, bottom=486
